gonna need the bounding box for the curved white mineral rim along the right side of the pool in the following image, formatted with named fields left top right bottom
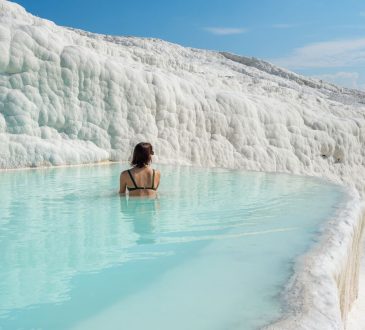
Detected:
left=263, top=188, right=365, bottom=330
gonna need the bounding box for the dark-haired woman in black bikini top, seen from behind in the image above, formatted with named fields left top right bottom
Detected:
left=119, top=142, right=160, bottom=197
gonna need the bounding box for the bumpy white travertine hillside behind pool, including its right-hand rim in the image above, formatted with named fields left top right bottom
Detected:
left=0, top=0, right=365, bottom=329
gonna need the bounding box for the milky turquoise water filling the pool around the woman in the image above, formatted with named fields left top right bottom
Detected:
left=0, top=164, right=344, bottom=330
